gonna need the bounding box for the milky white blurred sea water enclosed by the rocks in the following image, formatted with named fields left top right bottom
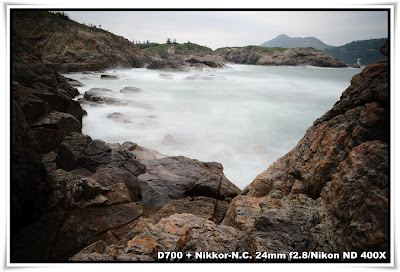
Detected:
left=66, top=65, right=361, bottom=189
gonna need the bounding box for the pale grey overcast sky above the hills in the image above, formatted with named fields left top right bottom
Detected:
left=68, top=11, right=388, bottom=49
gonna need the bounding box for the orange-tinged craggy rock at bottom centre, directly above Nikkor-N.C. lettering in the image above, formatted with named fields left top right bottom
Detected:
left=126, top=214, right=243, bottom=259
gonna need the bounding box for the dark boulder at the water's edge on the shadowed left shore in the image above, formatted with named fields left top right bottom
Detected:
left=31, top=111, right=82, bottom=153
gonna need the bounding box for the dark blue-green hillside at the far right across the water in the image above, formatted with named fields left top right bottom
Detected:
left=323, top=38, right=387, bottom=65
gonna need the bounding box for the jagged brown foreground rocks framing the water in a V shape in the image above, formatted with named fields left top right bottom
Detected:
left=10, top=11, right=390, bottom=262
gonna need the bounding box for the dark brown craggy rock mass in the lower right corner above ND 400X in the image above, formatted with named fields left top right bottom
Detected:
left=323, top=141, right=389, bottom=252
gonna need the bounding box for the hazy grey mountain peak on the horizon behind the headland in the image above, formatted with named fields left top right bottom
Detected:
left=260, top=34, right=332, bottom=50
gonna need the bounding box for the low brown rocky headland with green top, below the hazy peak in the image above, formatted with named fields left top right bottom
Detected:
left=215, top=46, right=346, bottom=67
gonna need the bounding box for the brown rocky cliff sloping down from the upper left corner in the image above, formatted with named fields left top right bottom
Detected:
left=12, top=11, right=150, bottom=72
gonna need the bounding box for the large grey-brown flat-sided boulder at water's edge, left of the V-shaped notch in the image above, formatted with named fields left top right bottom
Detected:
left=139, top=156, right=240, bottom=210
